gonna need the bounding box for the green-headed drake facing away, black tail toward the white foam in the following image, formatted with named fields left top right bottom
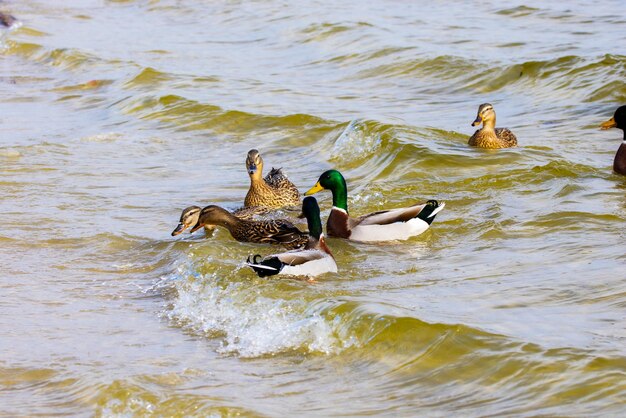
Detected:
left=247, top=197, right=337, bottom=277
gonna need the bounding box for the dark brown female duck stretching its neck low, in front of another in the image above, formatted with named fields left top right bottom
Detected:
left=190, top=205, right=308, bottom=249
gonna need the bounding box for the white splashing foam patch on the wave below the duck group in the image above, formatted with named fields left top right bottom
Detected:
left=158, top=262, right=354, bottom=357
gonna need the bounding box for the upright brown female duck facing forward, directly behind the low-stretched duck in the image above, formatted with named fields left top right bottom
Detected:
left=244, top=149, right=300, bottom=208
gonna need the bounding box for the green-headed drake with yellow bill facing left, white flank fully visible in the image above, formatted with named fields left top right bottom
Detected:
left=305, top=170, right=445, bottom=242
